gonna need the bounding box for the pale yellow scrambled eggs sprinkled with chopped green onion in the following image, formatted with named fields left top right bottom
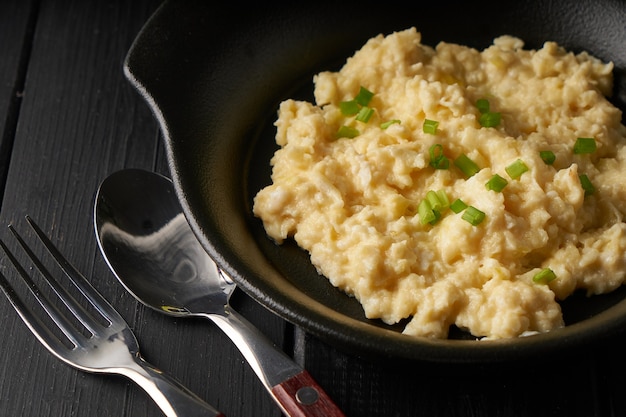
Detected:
left=254, top=28, right=626, bottom=339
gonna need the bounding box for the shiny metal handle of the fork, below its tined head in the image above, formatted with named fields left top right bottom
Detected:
left=127, top=356, right=224, bottom=417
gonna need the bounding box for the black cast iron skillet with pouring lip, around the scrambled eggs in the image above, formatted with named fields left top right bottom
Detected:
left=124, top=0, right=626, bottom=363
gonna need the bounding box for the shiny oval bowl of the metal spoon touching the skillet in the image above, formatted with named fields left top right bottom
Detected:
left=95, top=170, right=230, bottom=316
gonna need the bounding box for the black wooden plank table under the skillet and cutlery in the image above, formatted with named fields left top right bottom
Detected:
left=0, top=0, right=626, bottom=417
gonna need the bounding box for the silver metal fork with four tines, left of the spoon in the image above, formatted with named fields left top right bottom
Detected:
left=0, top=216, right=223, bottom=417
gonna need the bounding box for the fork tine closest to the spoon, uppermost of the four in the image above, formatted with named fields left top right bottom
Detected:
left=26, top=216, right=122, bottom=322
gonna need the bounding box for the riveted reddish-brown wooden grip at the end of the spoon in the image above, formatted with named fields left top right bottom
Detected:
left=272, top=370, right=345, bottom=417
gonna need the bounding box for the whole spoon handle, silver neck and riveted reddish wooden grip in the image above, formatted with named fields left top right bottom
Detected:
left=208, top=308, right=344, bottom=417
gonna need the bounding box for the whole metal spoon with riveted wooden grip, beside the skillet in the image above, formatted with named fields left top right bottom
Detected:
left=94, top=169, right=344, bottom=417
